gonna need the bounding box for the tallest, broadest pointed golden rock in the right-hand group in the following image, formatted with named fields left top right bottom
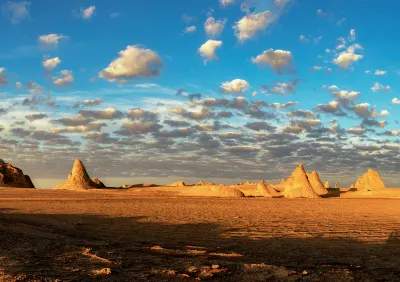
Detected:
left=283, top=164, right=319, bottom=198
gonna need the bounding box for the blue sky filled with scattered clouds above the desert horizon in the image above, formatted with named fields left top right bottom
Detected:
left=0, top=0, right=400, bottom=188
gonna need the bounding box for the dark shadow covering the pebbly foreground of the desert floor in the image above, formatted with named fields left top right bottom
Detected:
left=0, top=209, right=400, bottom=281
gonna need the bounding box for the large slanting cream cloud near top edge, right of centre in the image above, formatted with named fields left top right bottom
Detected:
left=233, top=11, right=273, bottom=42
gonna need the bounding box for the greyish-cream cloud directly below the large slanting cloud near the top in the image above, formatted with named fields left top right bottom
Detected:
left=252, top=49, right=293, bottom=74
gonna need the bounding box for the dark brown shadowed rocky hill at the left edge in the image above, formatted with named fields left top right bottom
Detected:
left=0, top=160, right=35, bottom=188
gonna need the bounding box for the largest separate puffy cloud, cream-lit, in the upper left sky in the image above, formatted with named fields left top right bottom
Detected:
left=99, top=45, right=164, bottom=82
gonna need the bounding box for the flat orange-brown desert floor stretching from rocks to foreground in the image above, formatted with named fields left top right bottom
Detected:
left=0, top=189, right=400, bottom=282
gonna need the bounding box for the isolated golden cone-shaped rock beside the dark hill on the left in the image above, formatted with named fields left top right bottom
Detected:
left=54, top=159, right=104, bottom=190
